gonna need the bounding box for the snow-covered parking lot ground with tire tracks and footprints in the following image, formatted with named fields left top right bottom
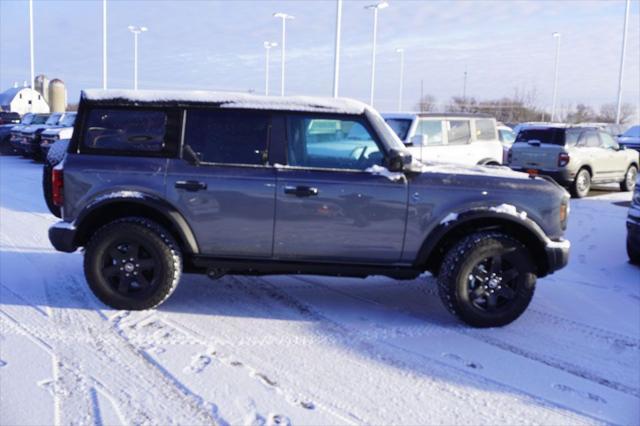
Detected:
left=0, top=157, right=640, bottom=425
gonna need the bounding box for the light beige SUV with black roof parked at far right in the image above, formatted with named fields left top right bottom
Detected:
left=509, top=126, right=640, bottom=198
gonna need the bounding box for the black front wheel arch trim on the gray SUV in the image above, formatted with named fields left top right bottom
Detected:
left=414, top=210, right=549, bottom=277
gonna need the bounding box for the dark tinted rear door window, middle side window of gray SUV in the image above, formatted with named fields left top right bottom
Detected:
left=184, top=109, right=270, bottom=165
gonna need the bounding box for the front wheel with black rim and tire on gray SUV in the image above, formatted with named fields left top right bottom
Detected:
left=438, top=232, right=536, bottom=327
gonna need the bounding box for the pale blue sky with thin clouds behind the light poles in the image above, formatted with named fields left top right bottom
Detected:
left=0, top=0, right=640, bottom=110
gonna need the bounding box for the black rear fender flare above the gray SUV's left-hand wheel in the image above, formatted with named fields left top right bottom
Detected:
left=73, top=190, right=200, bottom=254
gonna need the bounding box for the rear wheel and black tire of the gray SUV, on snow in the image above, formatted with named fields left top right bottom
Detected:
left=84, top=217, right=182, bottom=310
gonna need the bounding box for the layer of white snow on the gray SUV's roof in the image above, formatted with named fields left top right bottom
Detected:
left=82, top=89, right=367, bottom=114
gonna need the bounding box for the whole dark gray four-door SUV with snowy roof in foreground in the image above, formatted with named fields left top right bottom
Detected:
left=49, top=91, right=569, bottom=327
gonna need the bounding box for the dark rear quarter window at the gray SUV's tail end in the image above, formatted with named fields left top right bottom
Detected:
left=82, top=108, right=179, bottom=155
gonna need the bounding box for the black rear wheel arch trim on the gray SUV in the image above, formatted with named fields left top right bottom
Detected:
left=74, top=194, right=199, bottom=254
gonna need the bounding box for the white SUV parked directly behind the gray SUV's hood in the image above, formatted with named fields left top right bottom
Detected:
left=383, top=113, right=503, bottom=165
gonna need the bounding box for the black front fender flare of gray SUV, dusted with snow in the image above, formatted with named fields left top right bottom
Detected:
left=414, top=207, right=550, bottom=276
